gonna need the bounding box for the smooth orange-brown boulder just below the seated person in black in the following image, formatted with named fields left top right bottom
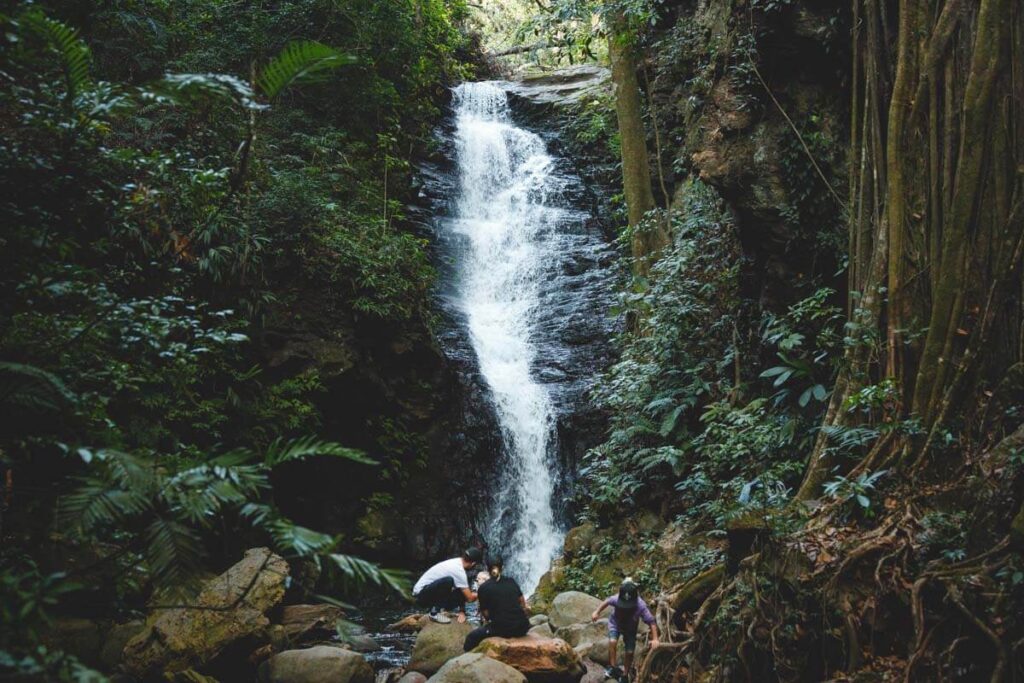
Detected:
left=473, top=635, right=586, bottom=683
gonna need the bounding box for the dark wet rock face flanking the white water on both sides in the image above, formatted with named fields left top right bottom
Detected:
left=417, top=72, right=616, bottom=548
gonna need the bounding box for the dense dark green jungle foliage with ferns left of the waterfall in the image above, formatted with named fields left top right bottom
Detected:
left=0, top=0, right=473, bottom=679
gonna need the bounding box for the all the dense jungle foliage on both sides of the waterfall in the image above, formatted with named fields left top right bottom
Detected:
left=0, top=0, right=1024, bottom=683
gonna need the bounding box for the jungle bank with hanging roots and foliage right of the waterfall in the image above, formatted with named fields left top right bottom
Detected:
left=536, top=0, right=1024, bottom=681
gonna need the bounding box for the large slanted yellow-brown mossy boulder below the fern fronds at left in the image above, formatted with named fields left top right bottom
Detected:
left=123, top=548, right=288, bottom=678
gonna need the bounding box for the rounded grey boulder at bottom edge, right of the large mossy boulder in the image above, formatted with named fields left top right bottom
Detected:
left=259, top=645, right=374, bottom=683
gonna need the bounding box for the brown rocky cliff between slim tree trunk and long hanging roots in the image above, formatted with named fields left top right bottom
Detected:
left=647, top=0, right=849, bottom=308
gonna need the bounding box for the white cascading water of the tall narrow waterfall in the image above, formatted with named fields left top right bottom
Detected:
left=450, top=83, right=564, bottom=593
